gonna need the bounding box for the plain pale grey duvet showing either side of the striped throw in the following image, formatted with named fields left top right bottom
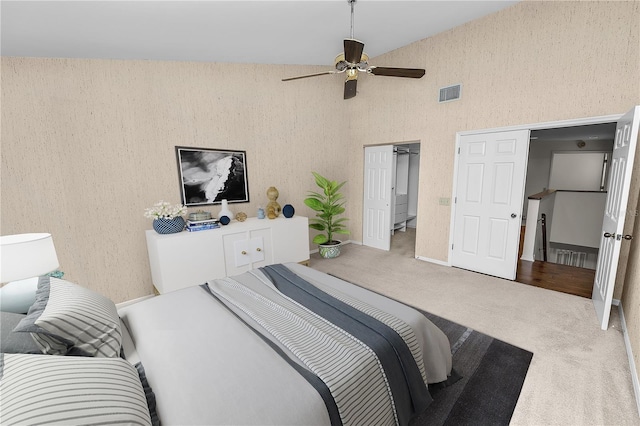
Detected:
left=119, top=264, right=451, bottom=425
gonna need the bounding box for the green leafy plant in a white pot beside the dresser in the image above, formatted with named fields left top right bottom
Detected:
left=304, top=172, right=349, bottom=259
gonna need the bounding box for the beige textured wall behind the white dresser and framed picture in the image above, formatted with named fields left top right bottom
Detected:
left=0, top=58, right=348, bottom=302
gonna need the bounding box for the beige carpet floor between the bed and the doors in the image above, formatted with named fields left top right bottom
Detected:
left=310, top=230, right=640, bottom=425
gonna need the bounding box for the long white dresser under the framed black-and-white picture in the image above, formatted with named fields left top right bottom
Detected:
left=146, top=216, right=309, bottom=293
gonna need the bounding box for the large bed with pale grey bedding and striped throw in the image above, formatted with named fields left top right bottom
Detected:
left=0, top=264, right=454, bottom=425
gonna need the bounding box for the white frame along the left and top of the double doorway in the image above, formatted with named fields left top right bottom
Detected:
left=446, top=114, right=633, bottom=266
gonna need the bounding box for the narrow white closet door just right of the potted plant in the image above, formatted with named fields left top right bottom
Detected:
left=362, top=145, right=394, bottom=250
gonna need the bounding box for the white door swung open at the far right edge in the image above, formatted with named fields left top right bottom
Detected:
left=591, top=106, right=640, bottom=330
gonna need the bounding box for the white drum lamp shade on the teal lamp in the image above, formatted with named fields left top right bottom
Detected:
left=0, top=234, right=60, bottom=283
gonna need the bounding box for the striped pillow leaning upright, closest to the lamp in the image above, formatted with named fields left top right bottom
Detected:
left=14, top=277, right=122, bottom=358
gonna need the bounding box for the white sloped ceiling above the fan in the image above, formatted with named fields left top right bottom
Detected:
left=0, top=0, right=517, bottom=65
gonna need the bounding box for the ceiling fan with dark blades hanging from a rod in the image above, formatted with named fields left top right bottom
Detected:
left=282, top=0, right=425, bottom=99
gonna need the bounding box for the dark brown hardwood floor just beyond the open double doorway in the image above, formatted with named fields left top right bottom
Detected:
left=516, top=260, right=596, bottom=298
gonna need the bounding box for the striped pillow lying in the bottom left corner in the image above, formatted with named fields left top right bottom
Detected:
left=0, top=354, right=151, bottom=425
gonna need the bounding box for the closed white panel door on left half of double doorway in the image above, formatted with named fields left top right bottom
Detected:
left=451, top=130, right=529, bottom=280
